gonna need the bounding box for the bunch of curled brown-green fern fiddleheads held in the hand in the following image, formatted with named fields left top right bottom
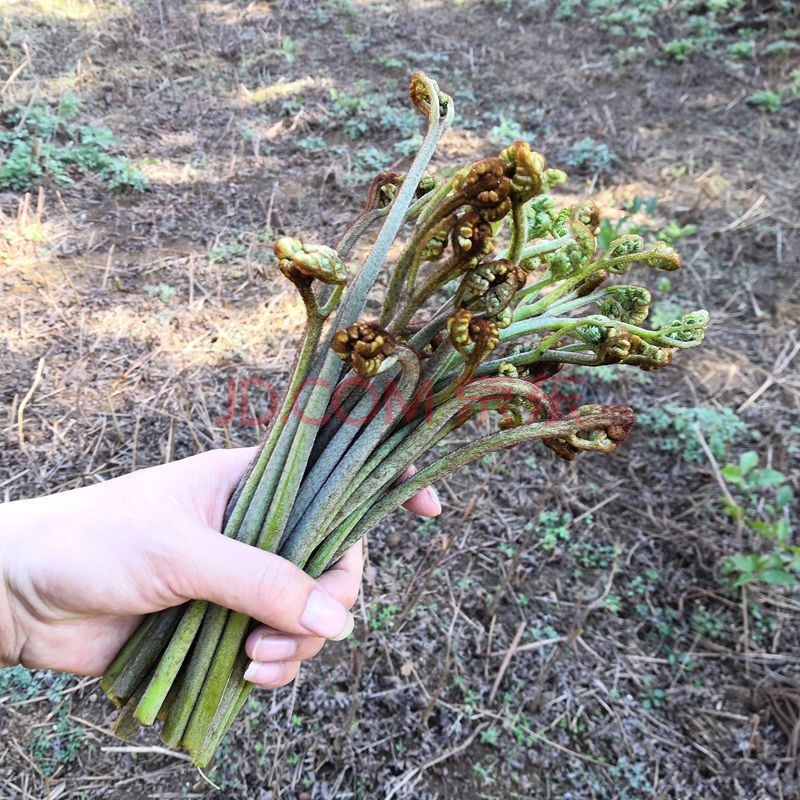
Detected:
left=102, top=72, right=708, bottom=766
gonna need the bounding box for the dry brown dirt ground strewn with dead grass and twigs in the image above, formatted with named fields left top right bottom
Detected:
left=0, top=0, right=800, bottom=800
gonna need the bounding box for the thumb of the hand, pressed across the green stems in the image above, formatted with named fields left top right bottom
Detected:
left=175, top=529, right=353, bottom=639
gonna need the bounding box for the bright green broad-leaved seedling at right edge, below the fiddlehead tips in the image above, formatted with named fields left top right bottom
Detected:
left=721, top=451, right=800, bottom=586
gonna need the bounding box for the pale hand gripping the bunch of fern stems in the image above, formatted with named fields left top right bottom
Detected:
left=0, top=448, right=441, bottom=688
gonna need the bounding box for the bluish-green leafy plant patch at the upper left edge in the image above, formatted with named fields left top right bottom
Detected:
left=0, top=95, right=147, bottom=191
